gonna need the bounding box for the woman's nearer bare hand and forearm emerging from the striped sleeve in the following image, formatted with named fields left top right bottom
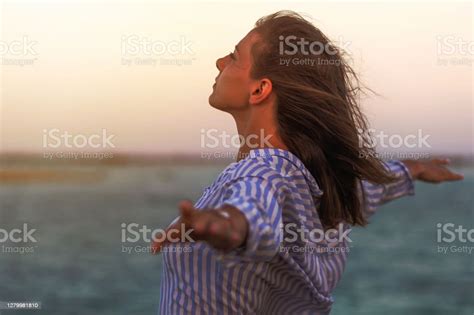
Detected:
left=151, top=201, right=248, bottom=254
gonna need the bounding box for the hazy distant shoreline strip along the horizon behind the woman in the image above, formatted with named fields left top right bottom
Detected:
left=0, top=152, right=474, bottom=184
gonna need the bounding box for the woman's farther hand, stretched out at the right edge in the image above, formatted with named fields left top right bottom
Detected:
left=402, top=159, right=464, bottom=184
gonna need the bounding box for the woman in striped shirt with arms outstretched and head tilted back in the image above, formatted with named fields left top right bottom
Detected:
left=153, top=12, right=462, bottom=314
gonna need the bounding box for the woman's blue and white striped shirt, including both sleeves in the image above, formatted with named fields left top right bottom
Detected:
left=159, top=148, right=414, bottom=314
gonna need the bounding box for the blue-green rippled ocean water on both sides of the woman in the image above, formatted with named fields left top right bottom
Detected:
left=0, top=165, right=474, bottom=315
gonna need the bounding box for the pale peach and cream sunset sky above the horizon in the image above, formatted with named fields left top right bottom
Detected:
left=0, top=0, right=474, bottom=154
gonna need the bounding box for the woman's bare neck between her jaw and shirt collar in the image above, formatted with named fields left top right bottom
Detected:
left=232, top=112, right=288, bottom=162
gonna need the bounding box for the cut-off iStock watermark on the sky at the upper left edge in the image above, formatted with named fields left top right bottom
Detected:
left=0, top=35, right=38, bottom=66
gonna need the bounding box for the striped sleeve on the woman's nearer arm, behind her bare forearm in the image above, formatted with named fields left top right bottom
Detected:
left=213, top=175, right=287, bottom=267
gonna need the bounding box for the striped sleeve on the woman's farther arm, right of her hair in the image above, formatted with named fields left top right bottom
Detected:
left=359, top=161, right=415, bottom=218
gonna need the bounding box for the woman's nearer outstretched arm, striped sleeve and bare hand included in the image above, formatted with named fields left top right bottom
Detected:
left=152, top=174, right=288, bottom=266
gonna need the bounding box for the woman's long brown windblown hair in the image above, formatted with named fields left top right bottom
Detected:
left=251, top=11, right=393, bottom=228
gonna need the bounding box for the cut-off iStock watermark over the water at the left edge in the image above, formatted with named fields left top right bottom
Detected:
left=0, top=223, right=38, bottom=254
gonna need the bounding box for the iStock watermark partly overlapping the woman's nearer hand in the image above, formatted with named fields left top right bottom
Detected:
left=121, top=223, right=195, bottom=254
